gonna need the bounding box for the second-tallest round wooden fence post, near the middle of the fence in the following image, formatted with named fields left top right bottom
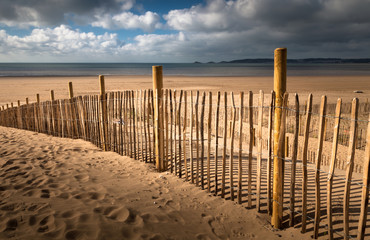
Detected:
left=152, top=66, right=167, bottom=172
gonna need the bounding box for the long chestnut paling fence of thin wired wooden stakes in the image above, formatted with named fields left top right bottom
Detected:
left=0, top=84, right=370, bottom=239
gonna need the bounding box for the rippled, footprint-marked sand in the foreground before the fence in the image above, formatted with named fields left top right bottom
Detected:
left=0, top=127, right=310, bottom=239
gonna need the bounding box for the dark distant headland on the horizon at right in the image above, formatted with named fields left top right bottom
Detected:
left=194, top=58, right=370, bottom=64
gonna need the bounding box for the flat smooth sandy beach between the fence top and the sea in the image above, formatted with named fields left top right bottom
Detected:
left=0, top=75, right=370, bottom=106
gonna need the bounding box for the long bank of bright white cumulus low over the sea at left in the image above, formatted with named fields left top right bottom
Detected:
left=0, top=25, right=122, bottom=61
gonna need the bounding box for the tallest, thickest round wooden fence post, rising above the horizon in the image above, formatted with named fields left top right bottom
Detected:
left=271, top=48, right=287, bottom=229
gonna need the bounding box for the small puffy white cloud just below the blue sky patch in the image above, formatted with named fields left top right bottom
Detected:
left=91, top=11, right=161, bottom=32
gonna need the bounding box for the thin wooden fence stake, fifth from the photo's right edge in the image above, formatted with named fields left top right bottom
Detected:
left=301, top=94, right=312, bottom=233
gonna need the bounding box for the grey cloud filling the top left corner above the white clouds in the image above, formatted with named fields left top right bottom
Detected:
left=0, top=0, right=132, bottom=26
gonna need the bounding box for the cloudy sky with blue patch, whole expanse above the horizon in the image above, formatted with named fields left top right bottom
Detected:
left=0, top=0, right=370, bottom=63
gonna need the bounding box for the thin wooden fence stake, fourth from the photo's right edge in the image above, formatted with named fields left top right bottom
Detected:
left=314, top=96, right=326, bottom=239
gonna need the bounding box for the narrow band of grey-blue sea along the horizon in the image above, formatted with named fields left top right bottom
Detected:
left=0, top=63, right=370, bottom=77
